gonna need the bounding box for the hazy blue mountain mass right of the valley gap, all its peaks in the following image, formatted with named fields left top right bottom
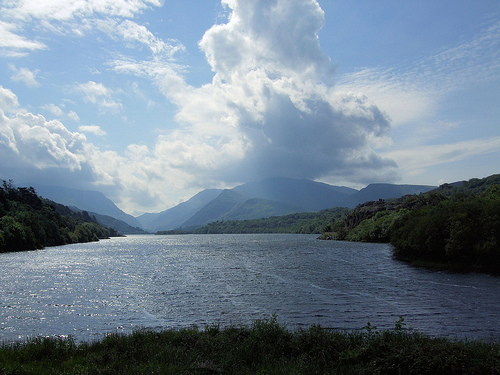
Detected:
left=138, top=178, right=433, bottom=232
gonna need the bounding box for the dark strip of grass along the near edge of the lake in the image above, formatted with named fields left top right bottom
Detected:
left=0, top=316, right=500, bottom=375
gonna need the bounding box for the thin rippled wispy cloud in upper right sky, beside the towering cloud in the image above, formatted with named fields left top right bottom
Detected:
left=336, top=21, right=500, bottom=127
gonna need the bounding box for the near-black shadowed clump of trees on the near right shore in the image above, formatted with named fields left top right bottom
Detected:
left=390, top=185, right=500, bottom=274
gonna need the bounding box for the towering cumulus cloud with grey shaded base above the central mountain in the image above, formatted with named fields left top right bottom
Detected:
left=114, top=0, right=396, bottom=189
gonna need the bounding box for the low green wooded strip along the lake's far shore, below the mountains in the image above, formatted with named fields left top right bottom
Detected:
left=157, top=208, right=349, bottom=234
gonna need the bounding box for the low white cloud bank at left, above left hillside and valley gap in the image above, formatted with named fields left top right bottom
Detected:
left=0, top=86, right=196, bottom=212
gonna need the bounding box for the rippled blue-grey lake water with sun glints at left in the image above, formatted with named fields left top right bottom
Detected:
left=0, top=235, right=500, bottom=341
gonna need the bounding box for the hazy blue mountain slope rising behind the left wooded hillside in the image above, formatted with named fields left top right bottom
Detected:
left=26, top=184, right=141, bottom=227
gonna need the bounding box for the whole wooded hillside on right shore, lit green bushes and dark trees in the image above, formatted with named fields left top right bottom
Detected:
left=324, top=175, right=500, bottom=274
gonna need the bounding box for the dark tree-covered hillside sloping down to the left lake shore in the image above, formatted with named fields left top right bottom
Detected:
left=0, top=181, right=117, bottom=252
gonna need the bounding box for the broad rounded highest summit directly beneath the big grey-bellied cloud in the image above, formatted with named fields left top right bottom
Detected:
left=233, top=178, right=357, bottom=212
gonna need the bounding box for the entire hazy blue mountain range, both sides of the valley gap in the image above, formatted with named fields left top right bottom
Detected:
left=27, top=178, right=435, bottom=234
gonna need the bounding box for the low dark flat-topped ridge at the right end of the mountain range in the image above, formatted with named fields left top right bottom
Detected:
left=349, top=183, right=436, bottom=207
